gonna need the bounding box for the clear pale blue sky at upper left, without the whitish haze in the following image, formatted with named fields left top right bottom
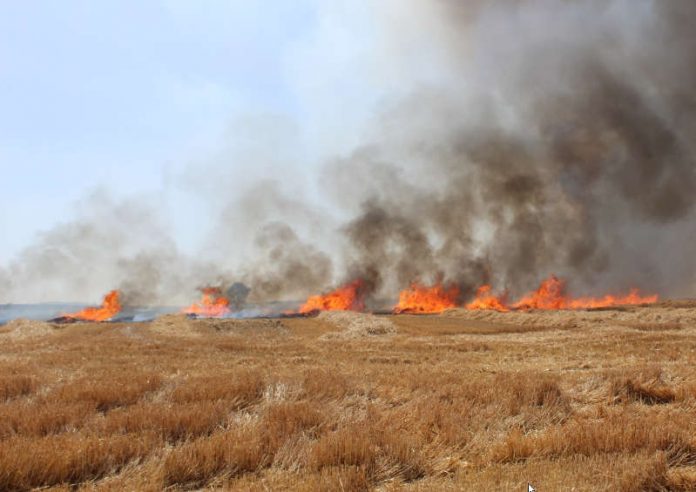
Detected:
left=0, top=0, right=317, bottom=264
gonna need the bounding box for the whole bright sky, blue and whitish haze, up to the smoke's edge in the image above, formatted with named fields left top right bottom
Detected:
left=0, top=0, right=454, bottom=267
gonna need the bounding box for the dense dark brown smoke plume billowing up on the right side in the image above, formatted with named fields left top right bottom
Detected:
left=322, top=0, right=696, bottom=300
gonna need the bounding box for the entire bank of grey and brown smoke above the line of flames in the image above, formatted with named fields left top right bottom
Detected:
left=0, top=0, right=696, bottom=303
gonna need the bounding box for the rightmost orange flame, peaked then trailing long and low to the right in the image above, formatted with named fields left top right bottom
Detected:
left=514, top=275, right=658, bottom=309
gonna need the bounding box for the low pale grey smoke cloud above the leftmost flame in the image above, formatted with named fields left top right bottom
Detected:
left=0, top=190, right=220, bottom=305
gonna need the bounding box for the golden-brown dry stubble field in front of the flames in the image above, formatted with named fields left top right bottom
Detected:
left=0, top=303, right=696, bottom=491
